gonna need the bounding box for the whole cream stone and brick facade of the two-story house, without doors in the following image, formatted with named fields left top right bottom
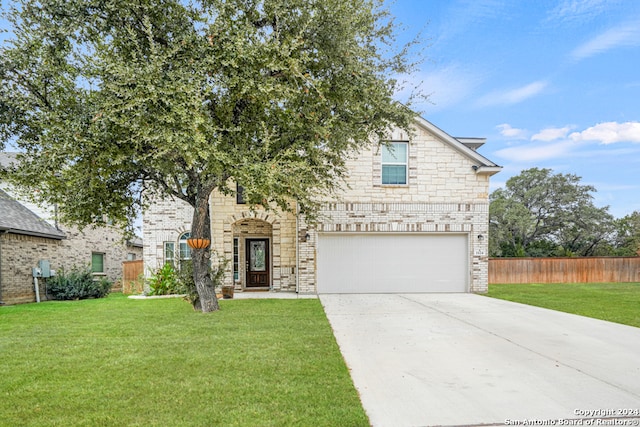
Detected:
left=144, top=119, right=499, bottom=293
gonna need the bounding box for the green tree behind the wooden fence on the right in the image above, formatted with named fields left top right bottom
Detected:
left=489, top=168, right=613, bottom=256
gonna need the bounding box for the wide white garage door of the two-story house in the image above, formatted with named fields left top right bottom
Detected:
left=317, top=233, right=469, bottom=294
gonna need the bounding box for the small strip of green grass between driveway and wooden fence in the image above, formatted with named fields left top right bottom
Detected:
left=488, top=283, right=640, bottom=327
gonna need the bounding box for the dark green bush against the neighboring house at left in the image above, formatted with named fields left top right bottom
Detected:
left=47, top=266, right=113, bottom=300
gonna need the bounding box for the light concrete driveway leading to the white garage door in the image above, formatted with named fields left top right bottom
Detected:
left=320, top=294, right=640, bottom=427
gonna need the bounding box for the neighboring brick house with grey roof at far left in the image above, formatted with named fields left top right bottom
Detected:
left=0, top=152, right=142, bottom=304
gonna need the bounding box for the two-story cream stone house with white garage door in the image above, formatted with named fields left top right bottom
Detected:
left=143, top=118, right=501, bottom=293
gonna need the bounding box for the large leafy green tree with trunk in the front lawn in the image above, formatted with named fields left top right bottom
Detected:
left=0, top=0, right=413, bottom=312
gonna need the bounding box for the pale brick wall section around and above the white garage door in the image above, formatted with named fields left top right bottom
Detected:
left=299, top=124, right=489, bottom=293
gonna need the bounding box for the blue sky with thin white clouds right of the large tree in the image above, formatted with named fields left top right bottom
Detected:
left=387, top=0, right=640, bottom=217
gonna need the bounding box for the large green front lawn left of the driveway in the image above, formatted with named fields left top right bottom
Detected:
left=0, top=294, right=369, bottom=426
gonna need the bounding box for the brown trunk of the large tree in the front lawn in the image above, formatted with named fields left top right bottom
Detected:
left=191, top=190, right=220, bottom=313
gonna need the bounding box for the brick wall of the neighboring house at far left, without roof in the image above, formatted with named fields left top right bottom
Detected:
left=0, top=227, right=142, bottom=304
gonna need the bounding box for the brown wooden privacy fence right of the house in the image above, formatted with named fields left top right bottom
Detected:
left=489, top=257, right=640, bottom=283
